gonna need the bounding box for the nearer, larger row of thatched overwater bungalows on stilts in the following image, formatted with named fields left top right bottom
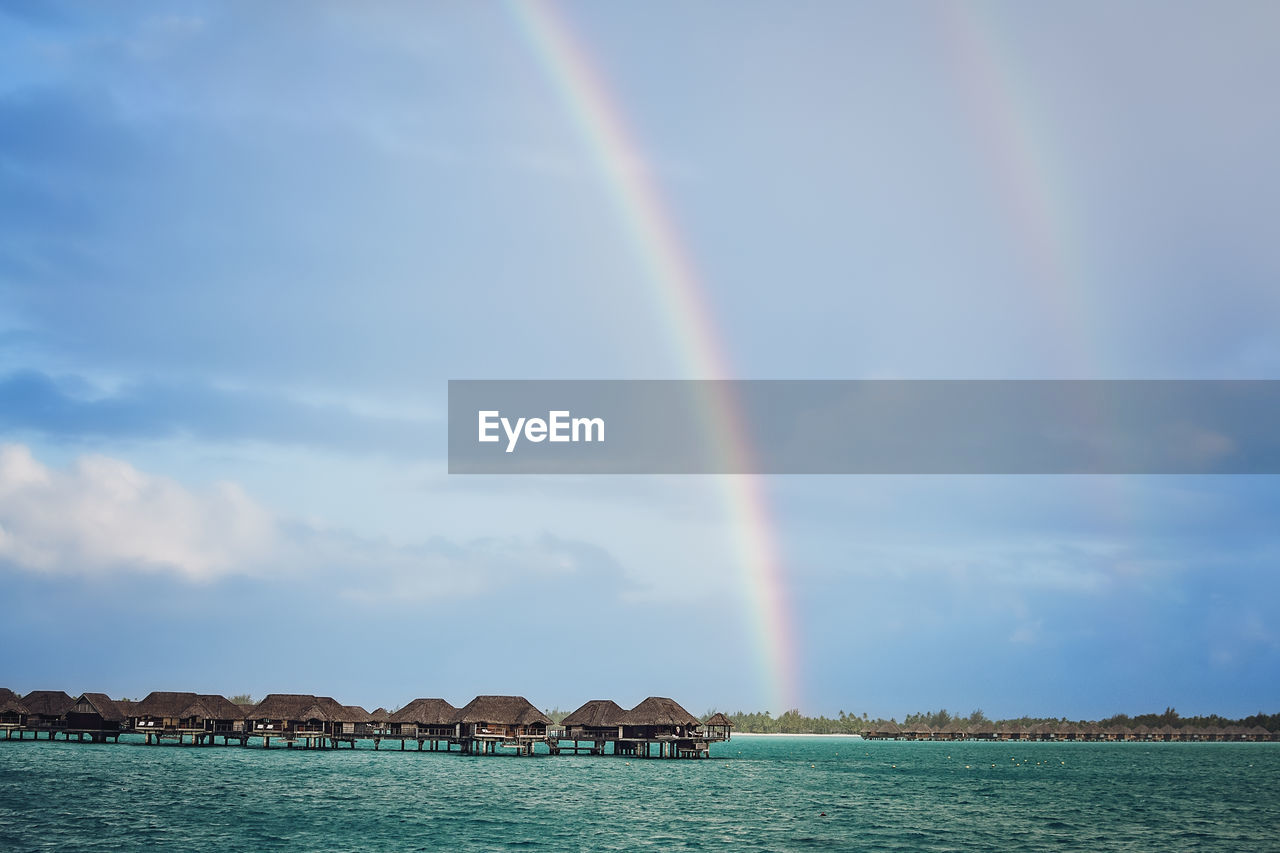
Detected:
left=0, top=688, right=732, bottom=758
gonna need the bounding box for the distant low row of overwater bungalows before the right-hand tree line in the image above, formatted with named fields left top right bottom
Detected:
left=861, top=722, right=1280, bottom=743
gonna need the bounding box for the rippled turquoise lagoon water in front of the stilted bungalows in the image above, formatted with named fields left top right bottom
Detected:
left=0, top=736, right=1280, bottom=852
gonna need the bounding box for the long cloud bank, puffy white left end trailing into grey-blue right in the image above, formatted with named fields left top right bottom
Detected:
left=0, top=444, right=634, bottom=605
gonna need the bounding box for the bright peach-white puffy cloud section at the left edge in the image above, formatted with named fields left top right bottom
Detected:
left=0, top=444, right=276, bottom=580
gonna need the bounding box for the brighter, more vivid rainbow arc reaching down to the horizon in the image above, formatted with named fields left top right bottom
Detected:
left=508, top=0, right=800, bottom=710
